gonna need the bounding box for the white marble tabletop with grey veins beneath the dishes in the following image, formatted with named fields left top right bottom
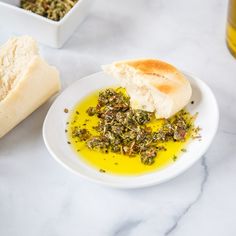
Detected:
left=0, top=0, right=236, bottom=236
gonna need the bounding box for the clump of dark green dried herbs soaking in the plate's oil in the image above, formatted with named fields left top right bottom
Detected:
left=72, top=89, right=197, bottom=165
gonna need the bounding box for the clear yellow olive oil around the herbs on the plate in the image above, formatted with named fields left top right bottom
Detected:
left=67, top=88, right=188, bottom=175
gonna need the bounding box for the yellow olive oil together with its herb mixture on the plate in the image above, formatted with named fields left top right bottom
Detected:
left=66, top=88, right=198, bottom=175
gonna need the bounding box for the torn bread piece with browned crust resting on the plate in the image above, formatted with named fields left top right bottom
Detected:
left=102, top=59, right=192, bottom=118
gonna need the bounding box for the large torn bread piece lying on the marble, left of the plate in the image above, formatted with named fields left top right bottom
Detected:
left=0, top=36, right=60, bottom=137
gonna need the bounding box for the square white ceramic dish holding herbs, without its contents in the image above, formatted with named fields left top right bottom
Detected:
left=0, top=0, right=93, bottom=48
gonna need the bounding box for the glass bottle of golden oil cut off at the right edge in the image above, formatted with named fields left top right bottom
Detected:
left=226, top=0, right=236, bottom=57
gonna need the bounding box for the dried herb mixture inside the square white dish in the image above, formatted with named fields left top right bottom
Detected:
left=20, top=0, right=78, bottom=21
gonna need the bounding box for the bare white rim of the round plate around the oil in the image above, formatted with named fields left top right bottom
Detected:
left=43, top=72, right=219, bottom=188
